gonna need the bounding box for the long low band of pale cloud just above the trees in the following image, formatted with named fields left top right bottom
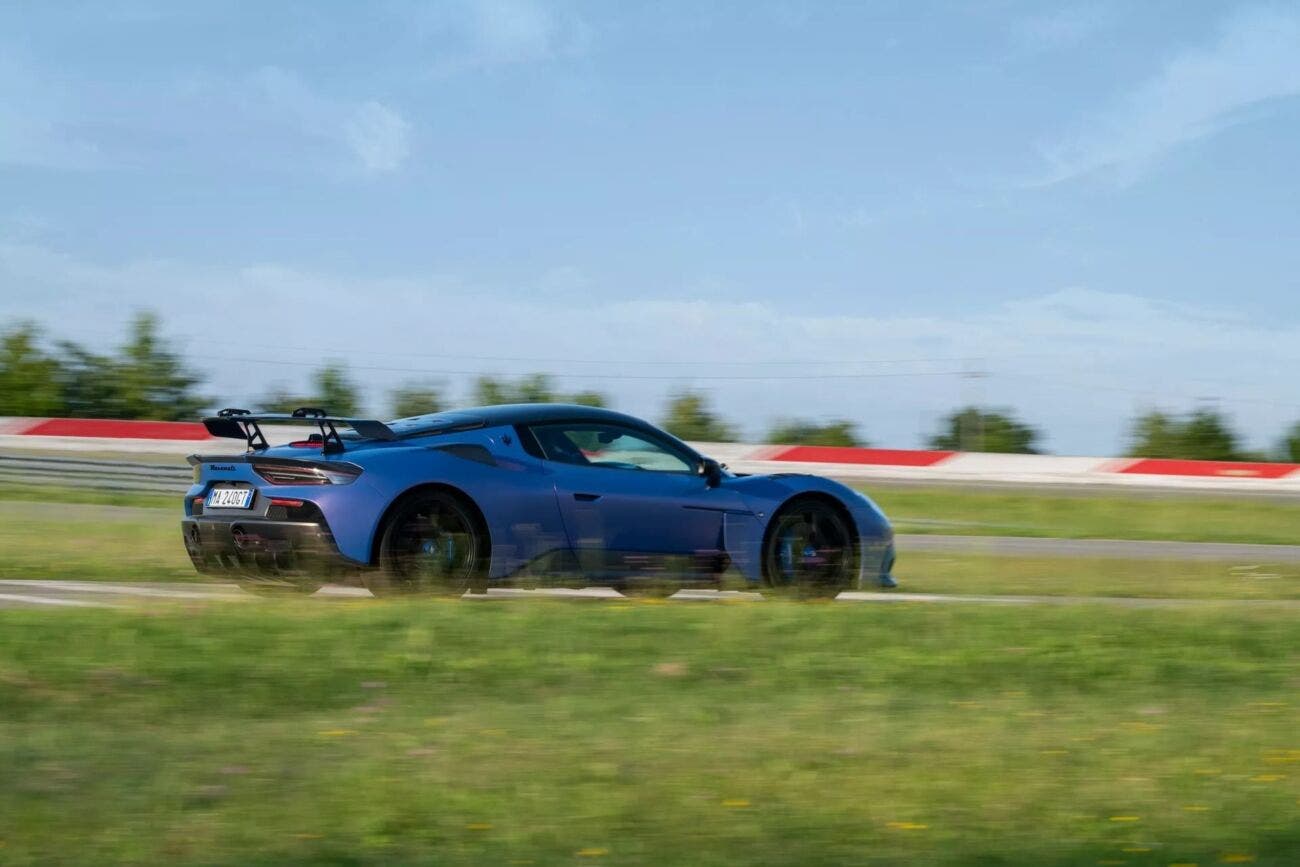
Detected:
left=0, top=243, right=1300, bottom=454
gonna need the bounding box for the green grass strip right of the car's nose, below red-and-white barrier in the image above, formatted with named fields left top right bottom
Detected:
left=859, top=485, right=1300, bottom=545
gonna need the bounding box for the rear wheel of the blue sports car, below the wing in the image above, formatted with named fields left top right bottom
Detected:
left=365, top=490, right=491, bottom=597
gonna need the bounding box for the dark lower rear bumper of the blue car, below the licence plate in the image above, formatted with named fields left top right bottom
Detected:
left=181, top=516, right=355, bottom=577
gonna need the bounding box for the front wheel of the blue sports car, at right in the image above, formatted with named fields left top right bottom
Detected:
left=763, top=497, right=858, bottom=598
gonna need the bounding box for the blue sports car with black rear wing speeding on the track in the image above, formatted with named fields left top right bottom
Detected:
left=182, top=404, right=894, bottom=595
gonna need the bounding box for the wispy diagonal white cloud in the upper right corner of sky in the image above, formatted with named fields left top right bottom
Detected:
left=1034, top=8, right=1300, bottom=186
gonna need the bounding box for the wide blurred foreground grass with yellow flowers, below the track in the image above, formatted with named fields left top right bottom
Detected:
left=0, top=602, right=1300, bottom=867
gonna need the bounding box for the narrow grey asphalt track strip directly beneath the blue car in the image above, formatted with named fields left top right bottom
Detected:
left=0, top=578, right=1300, bottom=610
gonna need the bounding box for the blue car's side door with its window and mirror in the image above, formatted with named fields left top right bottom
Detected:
left=532, top=422, right=745, bottom=575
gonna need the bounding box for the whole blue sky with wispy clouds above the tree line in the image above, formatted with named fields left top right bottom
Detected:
left=0, top=0, right=1300, bottom=454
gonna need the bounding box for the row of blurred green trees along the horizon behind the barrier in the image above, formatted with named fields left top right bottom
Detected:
left=0, top=313, right=1300, bottom=461
